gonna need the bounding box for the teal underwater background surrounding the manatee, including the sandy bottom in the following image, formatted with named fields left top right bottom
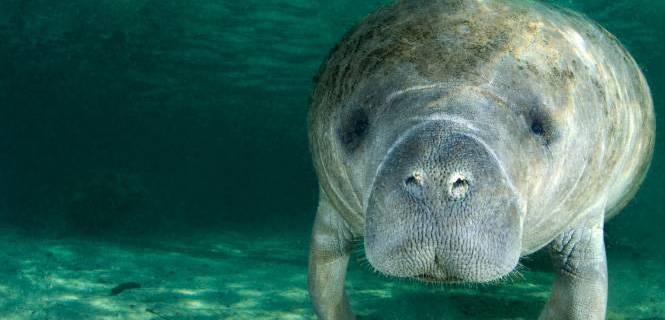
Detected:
left=0, top=0, right=665, bottom=319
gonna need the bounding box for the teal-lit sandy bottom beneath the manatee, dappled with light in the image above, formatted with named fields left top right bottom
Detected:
left=0, top=225, right=665, bottom=320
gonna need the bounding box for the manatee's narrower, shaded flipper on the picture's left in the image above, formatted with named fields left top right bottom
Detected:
left=308, top=192, right=354, bottom=320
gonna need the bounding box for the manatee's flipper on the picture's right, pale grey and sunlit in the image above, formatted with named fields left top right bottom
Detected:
left=540, top=205, right=607, bottom=320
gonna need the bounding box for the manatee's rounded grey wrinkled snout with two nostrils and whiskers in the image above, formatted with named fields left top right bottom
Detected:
left=365, top=121, right=523, bottom=282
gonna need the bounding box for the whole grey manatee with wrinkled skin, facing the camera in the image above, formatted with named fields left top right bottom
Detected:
left=309, top=0, right=655, bottom=319
